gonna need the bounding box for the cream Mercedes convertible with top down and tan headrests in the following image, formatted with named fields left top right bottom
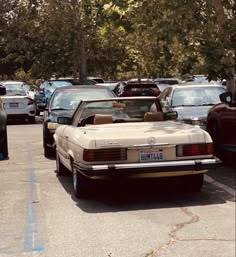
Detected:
left=54, top=97, right=220, bottom=197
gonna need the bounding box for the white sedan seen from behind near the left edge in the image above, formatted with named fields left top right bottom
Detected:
left=2, top=83, right=36, bottom=123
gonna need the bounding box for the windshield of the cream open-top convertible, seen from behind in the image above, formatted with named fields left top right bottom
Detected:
left=80, top=99, right=158, bottom=122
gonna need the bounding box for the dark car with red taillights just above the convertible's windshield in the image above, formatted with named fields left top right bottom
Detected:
left=114, top=81, right=160, bottom=97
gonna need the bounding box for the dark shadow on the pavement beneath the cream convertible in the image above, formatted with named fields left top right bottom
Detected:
left=55, top=171, right=232, bottom=213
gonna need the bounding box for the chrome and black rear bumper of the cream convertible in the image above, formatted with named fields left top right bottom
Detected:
left=74, top=157, right=221, bottom=177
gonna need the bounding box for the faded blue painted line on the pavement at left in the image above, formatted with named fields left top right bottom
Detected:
left=23, top=146, right=44, bottom=252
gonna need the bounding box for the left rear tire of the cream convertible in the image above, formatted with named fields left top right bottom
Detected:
left=72, top=165, right=88, bottom=198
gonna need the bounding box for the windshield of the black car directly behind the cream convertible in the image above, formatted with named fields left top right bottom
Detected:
left=50, top=88, right=114, bottom=110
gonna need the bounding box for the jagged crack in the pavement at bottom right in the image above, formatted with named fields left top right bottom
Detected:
left=145, top=204, right=199, bottom=257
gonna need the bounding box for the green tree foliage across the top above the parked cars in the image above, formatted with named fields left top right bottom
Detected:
left=0, top=0, right=236, bottom=87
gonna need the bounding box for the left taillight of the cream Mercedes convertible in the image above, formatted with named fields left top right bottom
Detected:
left=83, top=148, right=127, bottom=162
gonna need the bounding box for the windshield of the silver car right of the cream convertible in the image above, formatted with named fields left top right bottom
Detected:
left=172, top=86, right=225, bottom=107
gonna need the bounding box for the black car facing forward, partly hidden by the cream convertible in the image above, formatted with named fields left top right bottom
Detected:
left=43, top=85, right=115, bottom=157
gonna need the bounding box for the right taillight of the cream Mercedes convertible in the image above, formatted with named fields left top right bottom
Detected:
left=176, top=143, right=213, bottom=157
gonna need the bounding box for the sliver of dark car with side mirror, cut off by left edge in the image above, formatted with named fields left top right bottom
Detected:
left=0, top=85, right=8, bottom=160
